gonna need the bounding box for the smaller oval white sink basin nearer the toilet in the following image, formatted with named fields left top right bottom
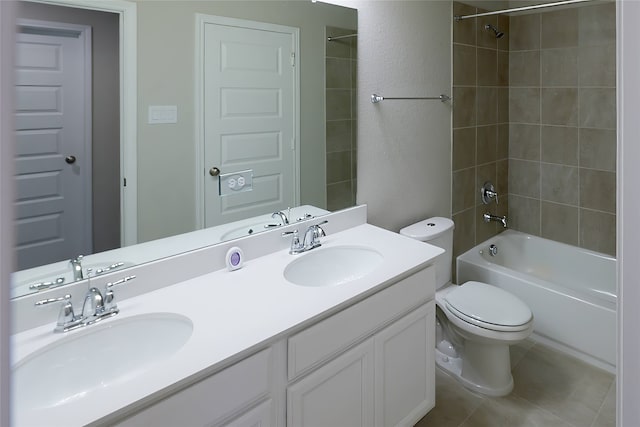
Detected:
left=284, top=246, right=383, bottom=287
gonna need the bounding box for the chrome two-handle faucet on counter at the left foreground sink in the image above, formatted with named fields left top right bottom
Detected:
left=35, top=276, right=136, bottom=332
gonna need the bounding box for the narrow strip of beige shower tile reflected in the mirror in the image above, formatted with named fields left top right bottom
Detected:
left=325, top=27, right=357, bottom=211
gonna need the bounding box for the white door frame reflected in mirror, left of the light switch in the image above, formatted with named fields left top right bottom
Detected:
left=22, top=0, right=138, bottom=246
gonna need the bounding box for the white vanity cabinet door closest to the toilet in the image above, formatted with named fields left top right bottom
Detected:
left=375, top=301, right=435, bottom=427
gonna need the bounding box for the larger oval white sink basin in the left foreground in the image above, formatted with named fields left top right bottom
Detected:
left=13, top=313, right=193, bottom=411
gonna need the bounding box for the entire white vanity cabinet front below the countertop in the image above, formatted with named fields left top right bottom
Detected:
left=114, top=267, right=435, bottom=427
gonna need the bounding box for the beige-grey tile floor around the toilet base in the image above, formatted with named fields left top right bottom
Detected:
left=415, top=341, right=616, bottom=427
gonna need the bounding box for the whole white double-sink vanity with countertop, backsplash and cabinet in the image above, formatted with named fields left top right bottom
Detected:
left=12, top=206, right=442, bottom=427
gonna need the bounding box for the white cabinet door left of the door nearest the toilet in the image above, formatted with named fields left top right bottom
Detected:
left=287, top=338, right=374, bottom=427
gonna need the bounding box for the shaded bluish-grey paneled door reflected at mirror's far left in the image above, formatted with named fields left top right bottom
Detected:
left=16, top=21, right=91, bottom=269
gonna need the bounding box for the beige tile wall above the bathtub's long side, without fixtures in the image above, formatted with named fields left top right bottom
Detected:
left=508, top=3, right=616, bottom=254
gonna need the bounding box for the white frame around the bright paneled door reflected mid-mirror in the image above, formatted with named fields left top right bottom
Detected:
left=194, top=13, right=300, bottom=229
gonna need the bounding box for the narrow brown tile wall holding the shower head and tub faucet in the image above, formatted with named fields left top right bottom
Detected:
left=452, top=2, right=510, bottom=274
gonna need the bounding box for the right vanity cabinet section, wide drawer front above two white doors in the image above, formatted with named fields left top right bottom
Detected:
left=287, top=268, right=435, bottom=427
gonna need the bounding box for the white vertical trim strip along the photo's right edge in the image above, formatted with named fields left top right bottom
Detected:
left=616, top=0, right=640, bottom=426
